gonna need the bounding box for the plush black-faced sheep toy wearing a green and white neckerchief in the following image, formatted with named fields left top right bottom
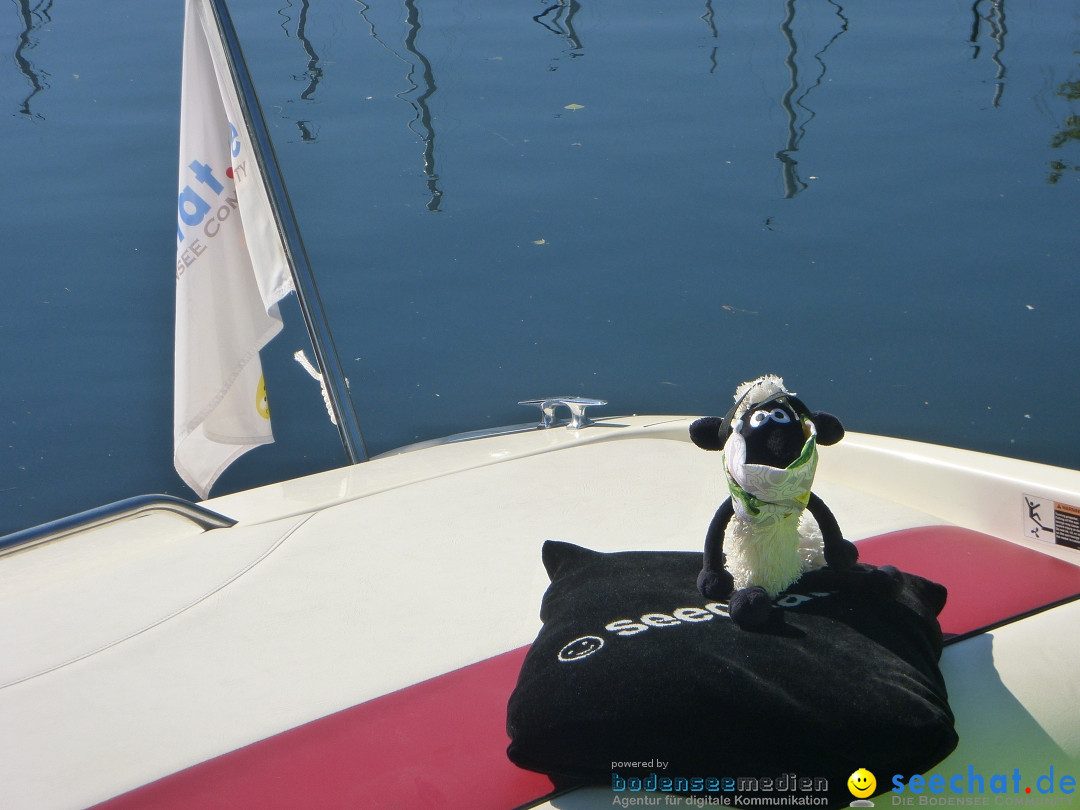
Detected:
left=690, top=375, right=900, bottom=627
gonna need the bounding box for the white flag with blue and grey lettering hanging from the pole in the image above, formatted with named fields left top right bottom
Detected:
left=173, top=0, right=293, bottom=498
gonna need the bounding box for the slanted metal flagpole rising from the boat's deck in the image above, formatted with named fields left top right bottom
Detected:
left=208, top=0, right=367, bottom=464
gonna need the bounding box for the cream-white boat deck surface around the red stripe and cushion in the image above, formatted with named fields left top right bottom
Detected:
left=0, top=417, right=1080, bottom=810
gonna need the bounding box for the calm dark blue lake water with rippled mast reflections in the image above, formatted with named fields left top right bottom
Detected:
left=0, top=0, right=1080, bottom=532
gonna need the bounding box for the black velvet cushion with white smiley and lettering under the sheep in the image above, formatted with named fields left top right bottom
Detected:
left=507, top=541, right=957, bottom=805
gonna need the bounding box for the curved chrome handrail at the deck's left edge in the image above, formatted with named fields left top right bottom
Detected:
left=0, top=495, right=237, bottom=557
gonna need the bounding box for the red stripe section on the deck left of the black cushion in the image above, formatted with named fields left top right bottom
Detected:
left=99, top=648, right=554, bottom=810
